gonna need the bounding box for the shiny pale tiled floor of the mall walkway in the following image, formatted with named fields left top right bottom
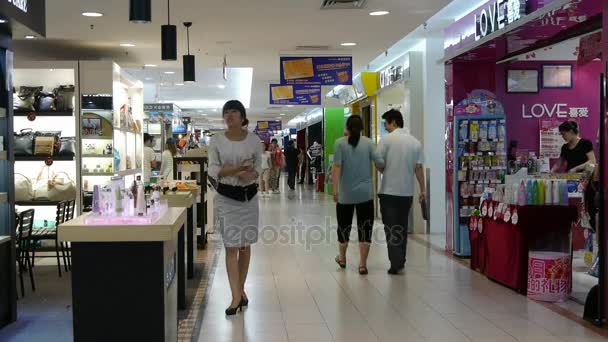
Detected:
left=199, top=187, right=606, bottom=342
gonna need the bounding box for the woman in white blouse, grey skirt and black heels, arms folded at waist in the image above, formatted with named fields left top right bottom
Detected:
left=209, top=100, right=262, bottom=316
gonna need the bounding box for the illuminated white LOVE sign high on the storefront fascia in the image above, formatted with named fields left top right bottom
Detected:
left=475, top=0, right=526, bottom=41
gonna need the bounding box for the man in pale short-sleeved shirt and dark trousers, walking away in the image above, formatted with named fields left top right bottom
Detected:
left=378, top=109, right=426, bottom=274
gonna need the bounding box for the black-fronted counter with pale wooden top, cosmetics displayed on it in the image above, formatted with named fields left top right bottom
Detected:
left=59, top=208, right=187, bottom=342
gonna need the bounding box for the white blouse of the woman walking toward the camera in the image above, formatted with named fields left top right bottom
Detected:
left=208, top=132, right=262, bottom=186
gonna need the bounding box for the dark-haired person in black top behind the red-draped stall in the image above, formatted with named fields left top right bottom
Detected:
left=551, top=121, right=596, bottom=172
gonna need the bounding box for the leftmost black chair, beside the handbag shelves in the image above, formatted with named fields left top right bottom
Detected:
left=15, top=209, right=36, bottom=297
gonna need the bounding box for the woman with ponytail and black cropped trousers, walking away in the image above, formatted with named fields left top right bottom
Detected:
left=332, top=115, right=384, bottom=274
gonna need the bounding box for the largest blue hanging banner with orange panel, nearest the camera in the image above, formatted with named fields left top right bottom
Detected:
left=281, top=56, right=353, bottom=86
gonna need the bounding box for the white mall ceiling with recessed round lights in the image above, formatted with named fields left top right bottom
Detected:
left=15, top=0, right=450, bottom=123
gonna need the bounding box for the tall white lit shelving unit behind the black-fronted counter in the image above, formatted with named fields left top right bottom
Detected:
left=81, top=61, right=144, bottom=211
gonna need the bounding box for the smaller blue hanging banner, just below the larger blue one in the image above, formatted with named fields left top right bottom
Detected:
left=270, top=84, right=321, bottom=106
